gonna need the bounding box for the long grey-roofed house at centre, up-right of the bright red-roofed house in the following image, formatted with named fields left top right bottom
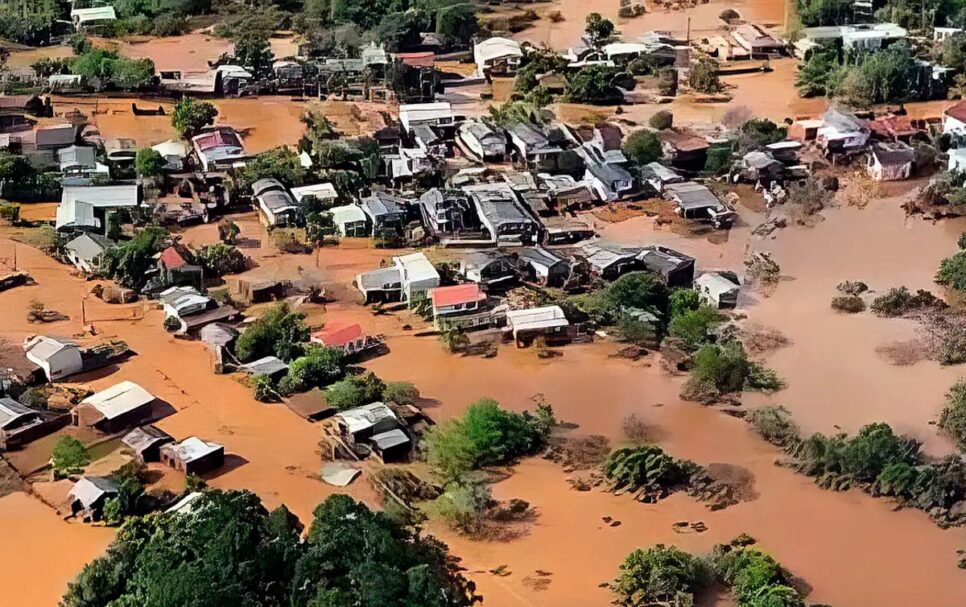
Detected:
left=463, top=183, right=540, bottom=246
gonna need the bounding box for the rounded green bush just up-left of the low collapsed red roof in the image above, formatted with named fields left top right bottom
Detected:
left=235, top=302, right=309, bottom=362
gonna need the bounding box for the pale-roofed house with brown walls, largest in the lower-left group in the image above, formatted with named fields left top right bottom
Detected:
left=71, top=381, right=156, bottom=433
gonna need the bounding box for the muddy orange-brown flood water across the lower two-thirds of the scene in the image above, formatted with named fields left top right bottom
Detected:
left=0, top=182, right=966, bottom=607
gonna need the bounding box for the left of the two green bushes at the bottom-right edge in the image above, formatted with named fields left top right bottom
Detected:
left=614, top=544, right=708, bottom=607
